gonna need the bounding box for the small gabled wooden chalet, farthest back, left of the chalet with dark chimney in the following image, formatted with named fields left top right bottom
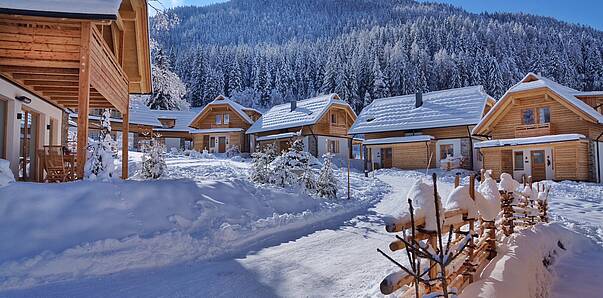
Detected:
left=189, top=96, right=262, bottom=153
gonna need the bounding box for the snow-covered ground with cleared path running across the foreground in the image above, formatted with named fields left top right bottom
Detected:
left=0, top=161, right=603, bottom=297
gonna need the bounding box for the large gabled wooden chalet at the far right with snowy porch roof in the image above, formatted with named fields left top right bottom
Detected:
left=473, top=73, right=603, bottom=181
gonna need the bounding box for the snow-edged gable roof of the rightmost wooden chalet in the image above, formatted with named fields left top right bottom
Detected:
left=472, top=72, right=603, bottom=134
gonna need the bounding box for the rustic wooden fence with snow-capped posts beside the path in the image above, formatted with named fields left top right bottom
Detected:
left=378, top=174, right=549, bottom=297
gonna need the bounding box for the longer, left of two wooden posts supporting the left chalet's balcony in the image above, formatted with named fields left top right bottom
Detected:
left=76, top=22, right=92, bottom=179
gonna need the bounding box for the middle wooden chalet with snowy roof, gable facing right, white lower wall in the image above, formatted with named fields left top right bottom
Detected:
left=247, top=94, right=356, bottom=159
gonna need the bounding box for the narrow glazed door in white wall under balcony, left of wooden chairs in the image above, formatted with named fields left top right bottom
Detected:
left=19, top=111, right=38, bottom=181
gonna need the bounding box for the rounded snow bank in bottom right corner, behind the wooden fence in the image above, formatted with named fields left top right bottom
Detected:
left=460, top=223, right=603, bottom=298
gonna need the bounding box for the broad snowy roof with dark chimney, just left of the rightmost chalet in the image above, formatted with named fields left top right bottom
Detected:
left=349, top=86, right=490, bottom=134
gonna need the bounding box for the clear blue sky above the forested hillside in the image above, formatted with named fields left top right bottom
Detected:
left=161, top=0, right=603, bottom=30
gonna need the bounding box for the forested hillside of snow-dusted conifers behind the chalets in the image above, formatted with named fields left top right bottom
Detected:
left=153, top=0, right=603, bottom=111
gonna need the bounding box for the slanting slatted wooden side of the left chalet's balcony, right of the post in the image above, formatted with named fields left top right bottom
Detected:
left=90, top=26, right=129, bottom=112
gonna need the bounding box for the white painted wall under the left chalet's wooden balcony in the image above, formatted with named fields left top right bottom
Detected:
left=0, top=77, right=63, bottom=177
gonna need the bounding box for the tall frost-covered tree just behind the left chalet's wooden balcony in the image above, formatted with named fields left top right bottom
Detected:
left=147, top=48, right=189, bottom=110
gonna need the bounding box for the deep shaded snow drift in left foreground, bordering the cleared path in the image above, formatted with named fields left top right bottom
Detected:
left=0, top=155, right=385, bottom=289
